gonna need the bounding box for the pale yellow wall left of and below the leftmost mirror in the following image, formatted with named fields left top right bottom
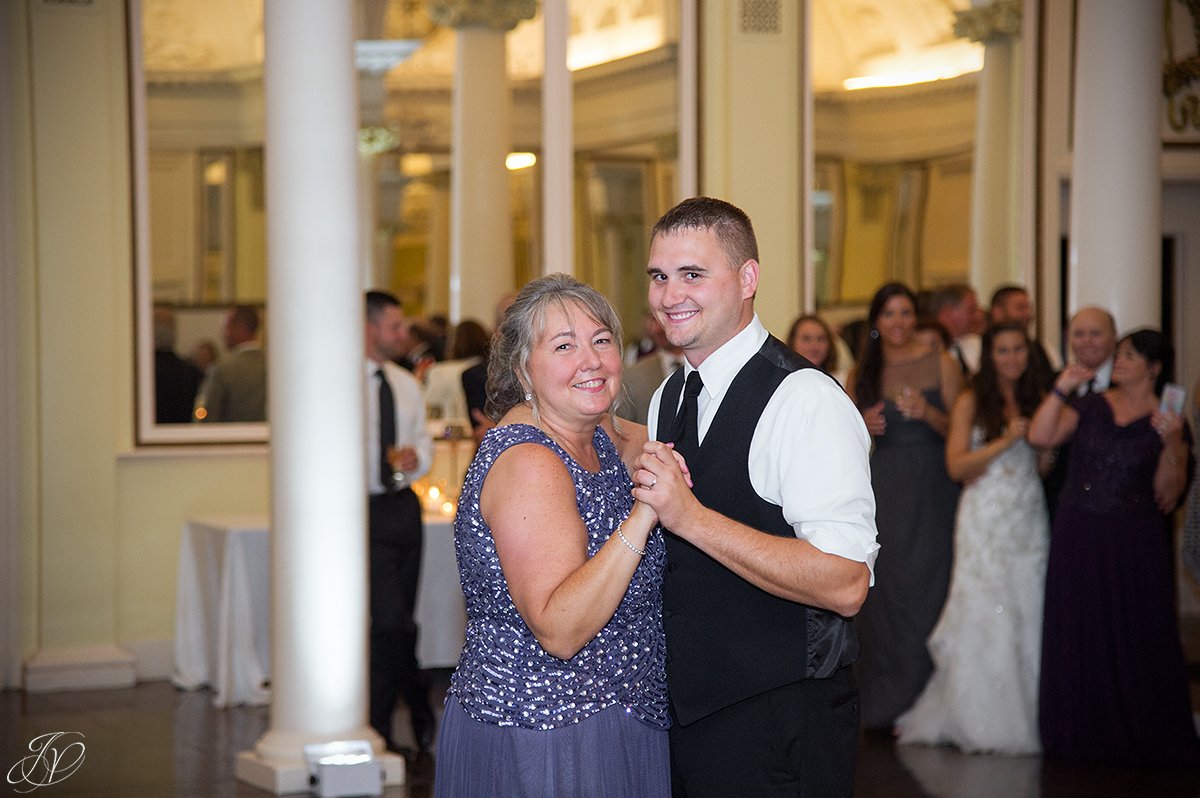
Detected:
left=2, top=0, right=268, bottom=676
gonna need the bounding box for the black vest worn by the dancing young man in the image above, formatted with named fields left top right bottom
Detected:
left=658, top=336, right=858, bottom=726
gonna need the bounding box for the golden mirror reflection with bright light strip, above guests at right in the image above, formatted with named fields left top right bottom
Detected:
left=809, top=0, right=990, bottom=338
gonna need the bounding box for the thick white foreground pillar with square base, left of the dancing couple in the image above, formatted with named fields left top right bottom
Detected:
left=238, top=0, right=403, bottom=794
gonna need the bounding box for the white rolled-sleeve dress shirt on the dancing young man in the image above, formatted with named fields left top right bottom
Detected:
left=648, top=314, right=880, bottom=584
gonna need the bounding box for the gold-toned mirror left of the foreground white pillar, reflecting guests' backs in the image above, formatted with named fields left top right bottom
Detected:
left=130, top=0, right=266, bottom=444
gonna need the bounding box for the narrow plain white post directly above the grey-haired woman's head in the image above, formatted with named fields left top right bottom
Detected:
left=542, top=0, right=575, bottom=276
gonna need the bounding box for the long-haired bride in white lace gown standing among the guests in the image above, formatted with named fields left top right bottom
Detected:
left=896, top=325, right=1049, bottom=754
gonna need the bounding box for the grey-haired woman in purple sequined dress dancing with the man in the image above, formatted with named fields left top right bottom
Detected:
left=434, top=275, right=671, bottom=797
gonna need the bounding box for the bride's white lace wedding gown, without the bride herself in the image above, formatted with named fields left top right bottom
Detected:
left=896, top=427, right=1049, bottom=754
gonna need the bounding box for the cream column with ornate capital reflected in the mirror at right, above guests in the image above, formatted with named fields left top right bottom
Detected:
left=954, top=0, right=1027, bottom=296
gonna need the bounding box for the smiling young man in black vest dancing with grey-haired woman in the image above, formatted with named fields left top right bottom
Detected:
left=634, top=197, right=878, bottom=798
